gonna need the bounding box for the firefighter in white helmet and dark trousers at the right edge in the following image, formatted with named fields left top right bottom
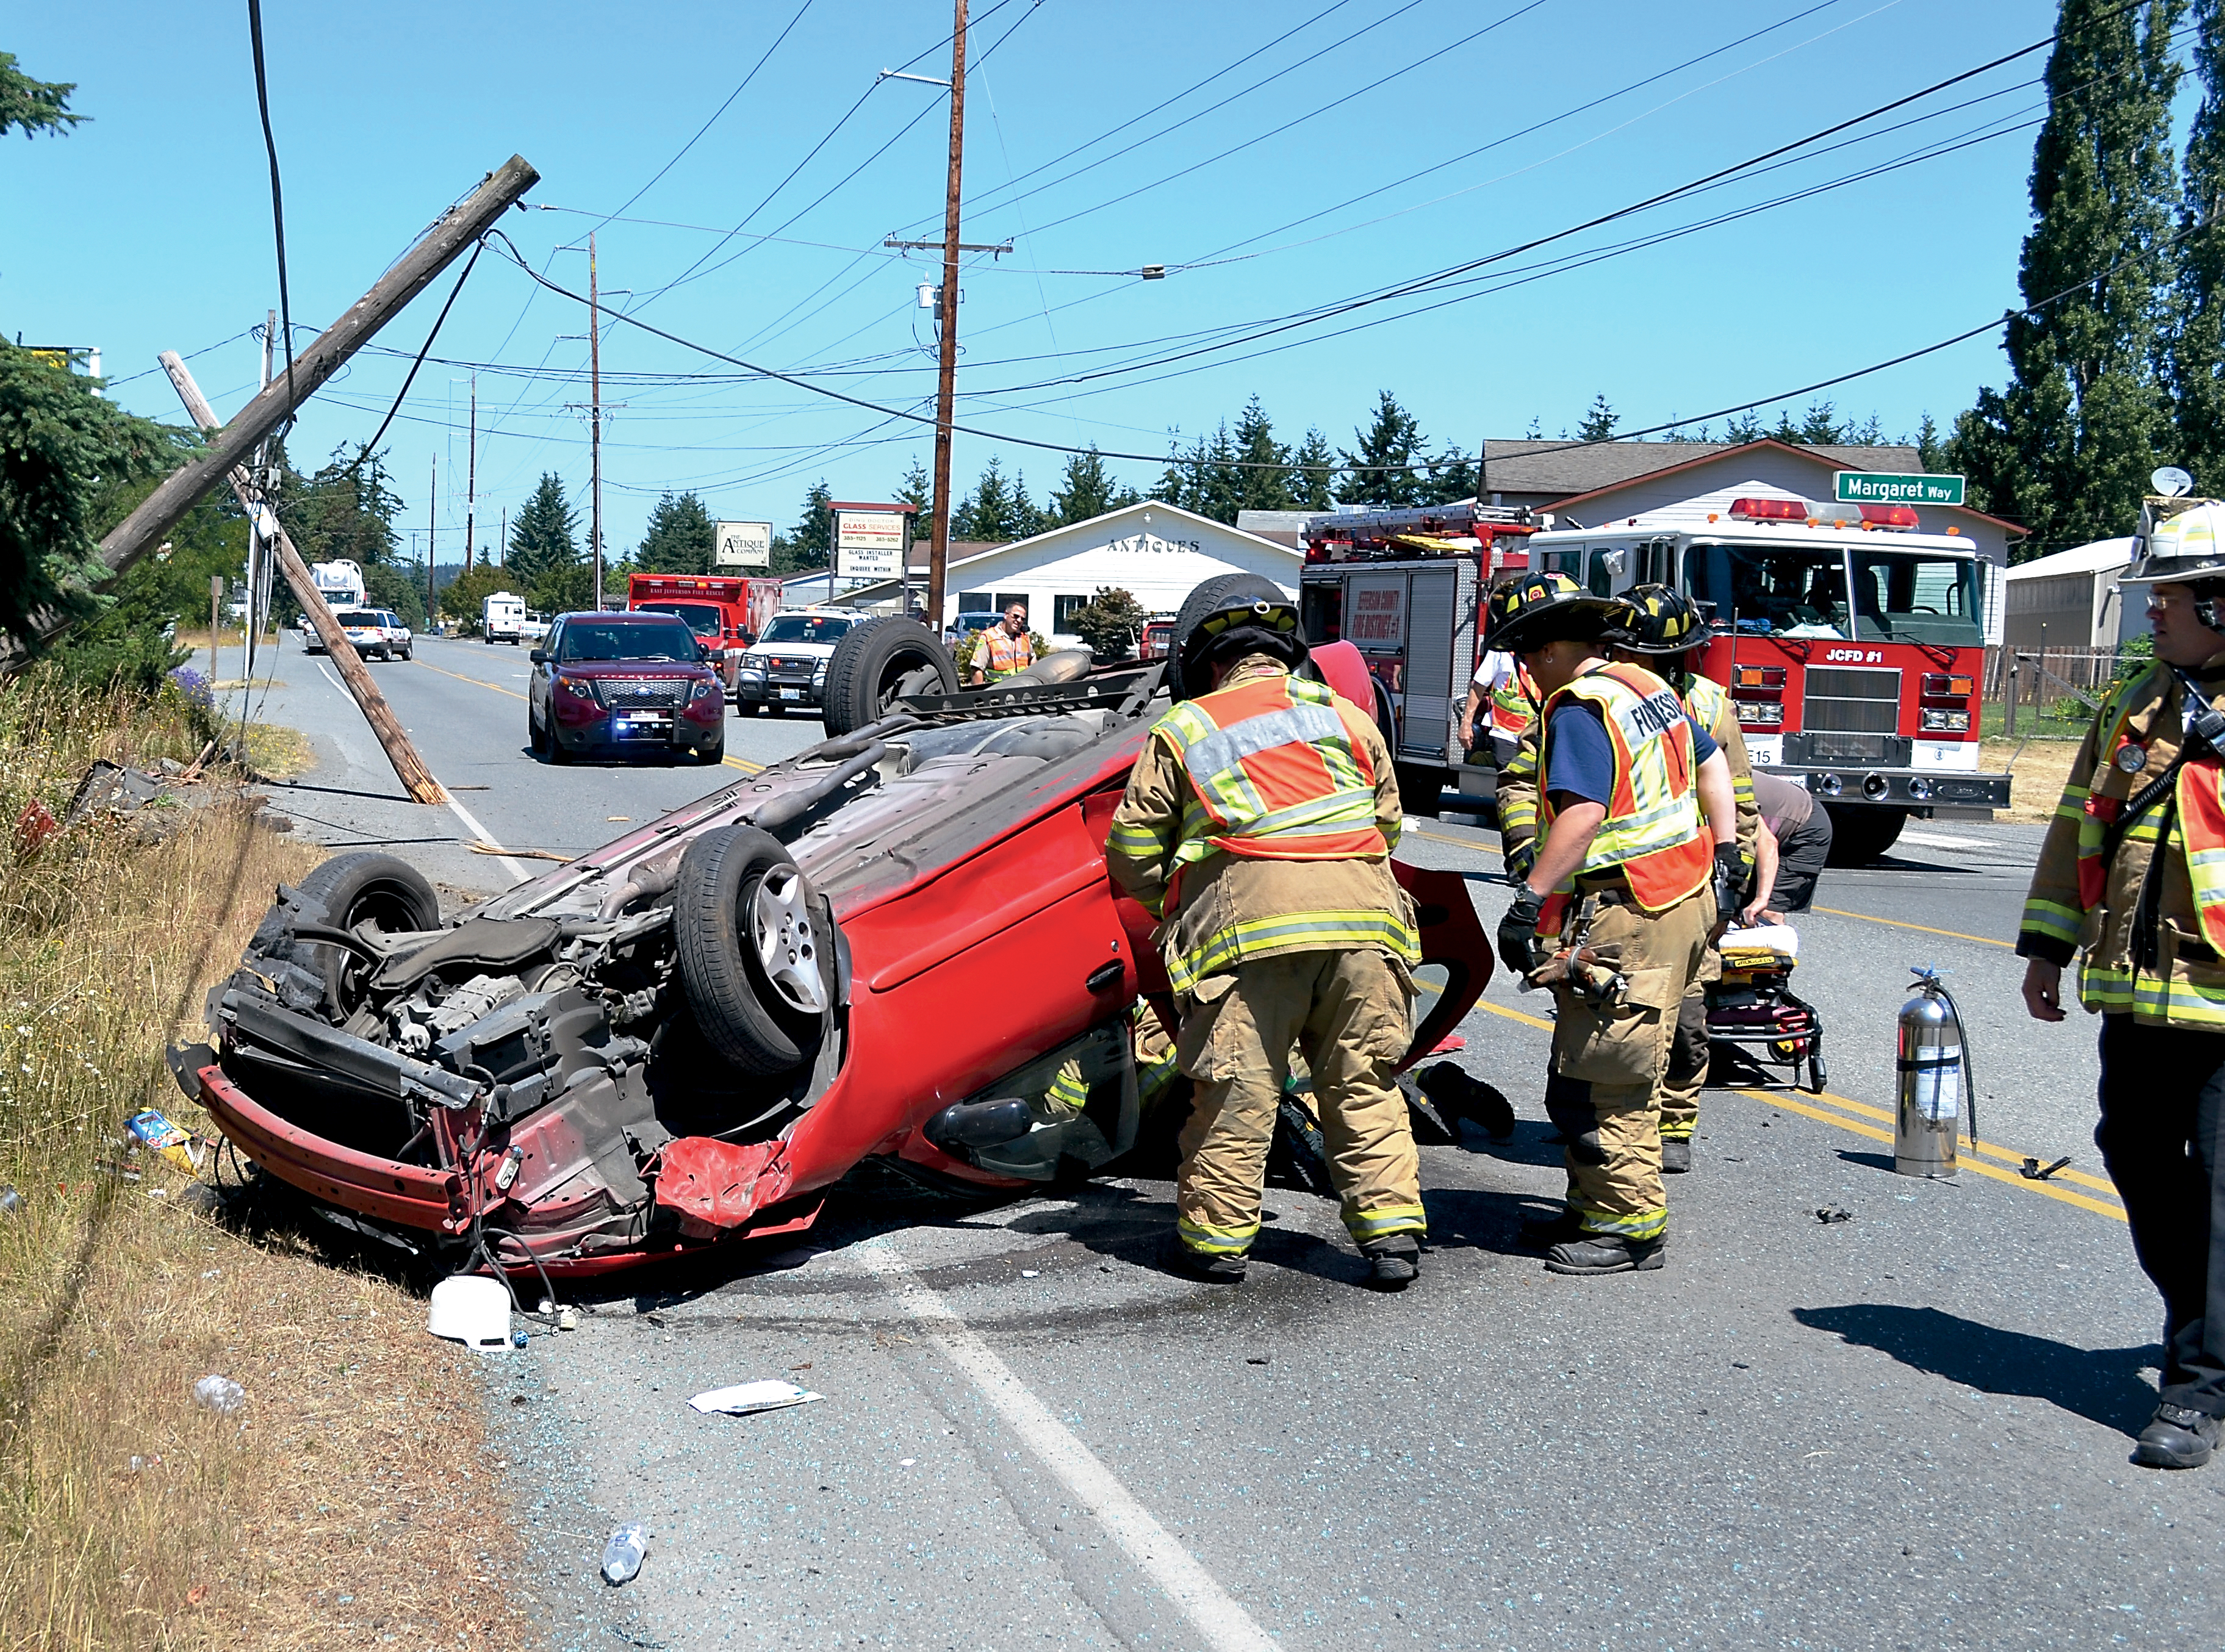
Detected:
left=2016, top=500, right=2225, bottom=1467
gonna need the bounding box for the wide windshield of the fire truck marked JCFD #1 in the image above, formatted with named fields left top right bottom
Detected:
left=1684, top=545, right=1985, bottom=647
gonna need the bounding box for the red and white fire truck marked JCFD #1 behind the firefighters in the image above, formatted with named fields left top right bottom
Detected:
left=1301, top=496, right=2009, bottom=863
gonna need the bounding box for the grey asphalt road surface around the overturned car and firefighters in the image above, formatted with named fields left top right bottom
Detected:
left=204, top=642, right=2225, bottom=1652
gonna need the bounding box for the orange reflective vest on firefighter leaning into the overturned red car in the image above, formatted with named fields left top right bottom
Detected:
left=1152, top=676, right=1390, bottom=900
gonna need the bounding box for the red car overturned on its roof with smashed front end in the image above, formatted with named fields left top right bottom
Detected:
left=173, top=587, right=1490, bottom=1274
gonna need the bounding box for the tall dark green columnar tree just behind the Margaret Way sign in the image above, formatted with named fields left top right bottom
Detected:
left=1949, top=0, right=2185, bottom=551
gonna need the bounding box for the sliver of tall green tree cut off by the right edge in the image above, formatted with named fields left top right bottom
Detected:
left=2171, top=0, right=2225, bottom=494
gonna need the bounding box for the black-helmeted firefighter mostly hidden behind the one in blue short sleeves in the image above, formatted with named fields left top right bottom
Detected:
left=1497, top=585, right=1762, bottom=1176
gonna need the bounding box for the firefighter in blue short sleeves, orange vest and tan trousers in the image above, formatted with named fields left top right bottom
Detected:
left=1484, top=573, right=1744, bottom=1274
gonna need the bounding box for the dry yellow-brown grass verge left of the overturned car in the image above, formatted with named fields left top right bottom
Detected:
left=0, top=685, right=523, bottom=1650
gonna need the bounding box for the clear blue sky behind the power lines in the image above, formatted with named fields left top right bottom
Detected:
left=0, top=0, right=2082, bottom=560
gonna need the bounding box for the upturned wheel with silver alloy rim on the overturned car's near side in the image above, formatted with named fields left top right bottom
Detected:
left=672, top=825, right=835, bottom=1074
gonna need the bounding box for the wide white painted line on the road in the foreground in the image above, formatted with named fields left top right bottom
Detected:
left=852, top=1238, right=1279, bottom=1652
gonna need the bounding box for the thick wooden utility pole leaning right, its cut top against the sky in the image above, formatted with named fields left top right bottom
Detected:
left=46, top=156, right=541, bottom=669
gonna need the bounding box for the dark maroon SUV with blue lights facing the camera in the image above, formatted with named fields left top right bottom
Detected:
left=525, top=614, right=725, bottom=763
